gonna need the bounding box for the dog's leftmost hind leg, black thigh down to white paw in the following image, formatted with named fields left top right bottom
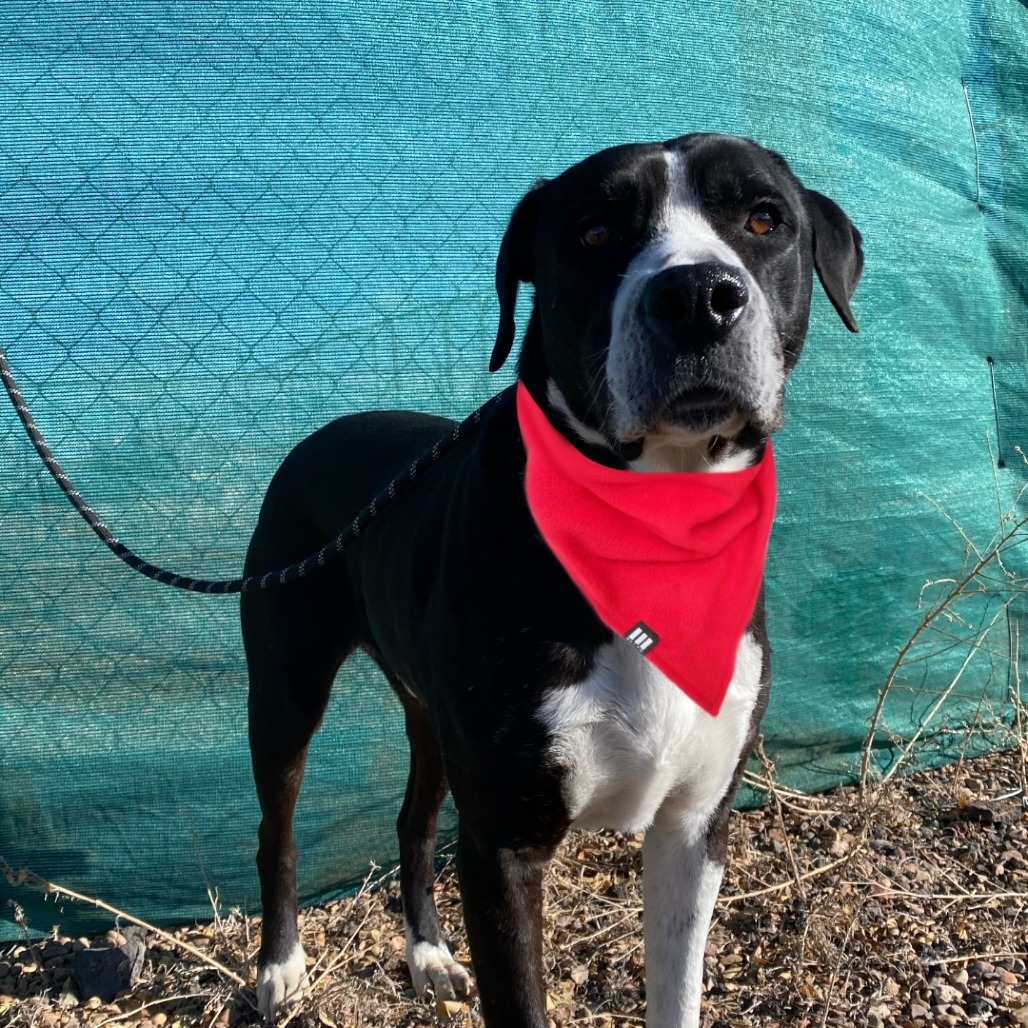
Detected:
left=243, top=586, right=346, bottom=1021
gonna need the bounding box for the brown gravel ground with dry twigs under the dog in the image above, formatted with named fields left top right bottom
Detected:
left=0, top=747, right=1028, bottom=1028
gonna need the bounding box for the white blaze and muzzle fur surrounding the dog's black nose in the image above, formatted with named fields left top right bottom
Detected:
left=607, top=151, right=785, bottom=440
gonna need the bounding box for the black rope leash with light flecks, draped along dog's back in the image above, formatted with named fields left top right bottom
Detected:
left=0, top=347, right=499, bottom=593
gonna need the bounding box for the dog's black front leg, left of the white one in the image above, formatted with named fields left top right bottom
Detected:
left=456, top=814, right=553, bottom=1028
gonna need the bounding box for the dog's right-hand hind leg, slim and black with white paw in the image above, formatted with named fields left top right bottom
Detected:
left=387, top=686, right=471, bottom=999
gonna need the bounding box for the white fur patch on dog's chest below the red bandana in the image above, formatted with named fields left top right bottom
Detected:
left=539, top=632, right=763, bottom=832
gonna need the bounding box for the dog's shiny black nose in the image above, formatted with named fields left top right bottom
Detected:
left=641, top=261, right=749, bottom=351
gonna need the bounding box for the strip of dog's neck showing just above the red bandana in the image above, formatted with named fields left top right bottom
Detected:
left=529, top=378, right=765, bottom=473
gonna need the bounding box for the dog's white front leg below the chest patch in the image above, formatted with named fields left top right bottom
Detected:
left=643, top=807, right=727, bottom=1028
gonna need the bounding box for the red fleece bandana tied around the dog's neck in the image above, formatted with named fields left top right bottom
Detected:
left=517, top=382, right=776, bottom=717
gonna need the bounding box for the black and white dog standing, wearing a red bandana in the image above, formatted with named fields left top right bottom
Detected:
left=242, top=135, right=862, bottom=1028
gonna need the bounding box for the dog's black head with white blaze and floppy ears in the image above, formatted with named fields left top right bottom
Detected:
left=489, top=135, right=864, bottom=470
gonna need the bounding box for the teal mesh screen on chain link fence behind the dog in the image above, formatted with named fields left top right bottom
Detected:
left=0, top=0, right=1028, bottom=938
